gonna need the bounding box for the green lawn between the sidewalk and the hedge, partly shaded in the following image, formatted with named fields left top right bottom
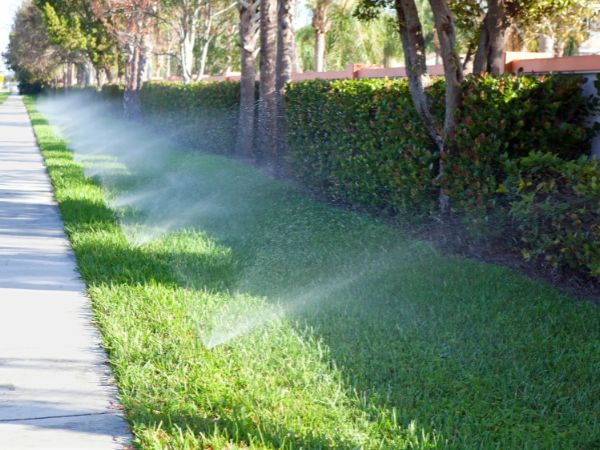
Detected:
left=27, top=99, right=600, bottom=449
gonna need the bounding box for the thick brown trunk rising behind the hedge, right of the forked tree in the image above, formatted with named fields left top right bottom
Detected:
left=473, top=0, right=509, bottom=76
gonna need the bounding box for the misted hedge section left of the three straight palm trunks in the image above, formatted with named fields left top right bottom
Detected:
left=141, top=82, right=240, bottom=154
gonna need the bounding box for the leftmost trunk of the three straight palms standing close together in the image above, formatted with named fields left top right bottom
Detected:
left=235, top=0, right=258, bottom=160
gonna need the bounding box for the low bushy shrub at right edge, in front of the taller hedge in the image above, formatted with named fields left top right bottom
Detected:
left=506, top=153, right=600, bottom=277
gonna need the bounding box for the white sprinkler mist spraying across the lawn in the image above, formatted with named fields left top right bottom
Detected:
left=39, top=94, right=432, bottom=348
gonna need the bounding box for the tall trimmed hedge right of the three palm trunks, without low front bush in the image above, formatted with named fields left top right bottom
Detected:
left=286, top=76, right=592, bottom=221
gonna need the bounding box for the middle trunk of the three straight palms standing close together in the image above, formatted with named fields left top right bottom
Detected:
left=258, top=0, right=277, bottom=165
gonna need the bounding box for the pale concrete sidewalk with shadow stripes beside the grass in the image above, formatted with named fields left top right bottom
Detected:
left=0, top=96, right=130, bottom=450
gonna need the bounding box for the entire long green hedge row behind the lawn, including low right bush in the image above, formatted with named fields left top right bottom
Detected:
left=91, top=75, right=600, bottom=277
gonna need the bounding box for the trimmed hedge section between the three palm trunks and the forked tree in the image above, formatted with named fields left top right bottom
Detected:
left=285, top=80, right=437, bottom=218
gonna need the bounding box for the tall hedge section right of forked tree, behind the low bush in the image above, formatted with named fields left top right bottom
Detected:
left=443, top=75, right=596, bottom=229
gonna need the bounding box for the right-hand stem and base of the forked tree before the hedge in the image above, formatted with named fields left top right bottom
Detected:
left=429, top=0, right=463, bottom=214
